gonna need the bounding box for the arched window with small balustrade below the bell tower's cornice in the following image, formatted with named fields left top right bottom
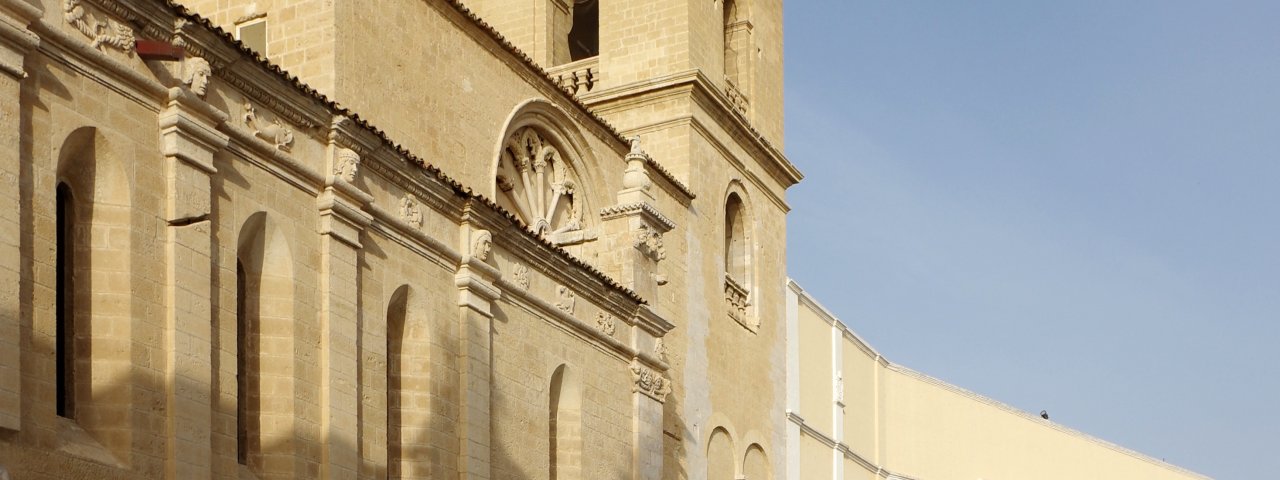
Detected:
left=724, top=192, right=755, bottom=330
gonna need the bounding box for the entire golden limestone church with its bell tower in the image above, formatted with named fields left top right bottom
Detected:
left=0, top=0, right=801, bottom=480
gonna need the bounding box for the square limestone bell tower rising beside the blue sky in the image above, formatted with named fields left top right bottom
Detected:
left=465, top=0, right=801, bottom=479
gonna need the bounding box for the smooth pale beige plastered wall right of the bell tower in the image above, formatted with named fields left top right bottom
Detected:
left=788, top=282, right=1204, bottom=480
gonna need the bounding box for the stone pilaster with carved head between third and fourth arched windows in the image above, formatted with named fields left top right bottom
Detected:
left=453, top=224, right=502, bottom=480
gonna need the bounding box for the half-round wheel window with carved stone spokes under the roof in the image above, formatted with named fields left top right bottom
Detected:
left=495, top=127, right=594, bottom=246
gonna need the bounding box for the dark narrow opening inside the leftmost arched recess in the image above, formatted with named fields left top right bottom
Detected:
left=55, top=183, right=76, bottom=419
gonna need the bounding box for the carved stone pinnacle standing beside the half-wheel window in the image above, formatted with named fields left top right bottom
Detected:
left=600, top=138, right=676, bottom=302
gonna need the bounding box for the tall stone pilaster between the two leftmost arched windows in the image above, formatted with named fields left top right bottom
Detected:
left=159, top=87, right=228, bottom=479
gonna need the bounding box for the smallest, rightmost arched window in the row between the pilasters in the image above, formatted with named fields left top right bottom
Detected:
left=548, top=365, right=582, bottom=480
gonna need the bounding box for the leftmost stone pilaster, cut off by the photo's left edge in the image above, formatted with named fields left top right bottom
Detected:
left=0, top=0, right=41, bottom=430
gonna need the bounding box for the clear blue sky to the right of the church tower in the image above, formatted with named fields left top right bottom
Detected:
left=785, top=0, right=1280, bottom=479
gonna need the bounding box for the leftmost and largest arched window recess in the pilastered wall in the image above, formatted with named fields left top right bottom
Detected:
left=49, top=127, right=137, bottom=458
